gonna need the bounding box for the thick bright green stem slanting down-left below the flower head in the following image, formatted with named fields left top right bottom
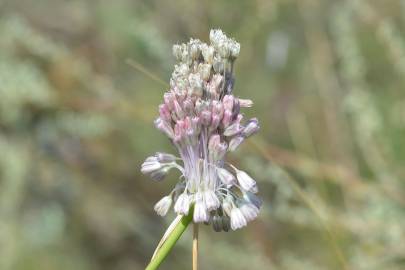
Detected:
left=145, top=207, right=193, bottom=270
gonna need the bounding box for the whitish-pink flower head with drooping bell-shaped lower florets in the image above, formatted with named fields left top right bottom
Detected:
left=141, top=30, right=261, bottom=231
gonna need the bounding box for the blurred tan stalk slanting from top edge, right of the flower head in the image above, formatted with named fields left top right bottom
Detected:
left=296, top=0, right=357, bottom=171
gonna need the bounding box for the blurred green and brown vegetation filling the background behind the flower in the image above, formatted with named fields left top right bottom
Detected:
left=0, top=0, right=405, bottom=270
